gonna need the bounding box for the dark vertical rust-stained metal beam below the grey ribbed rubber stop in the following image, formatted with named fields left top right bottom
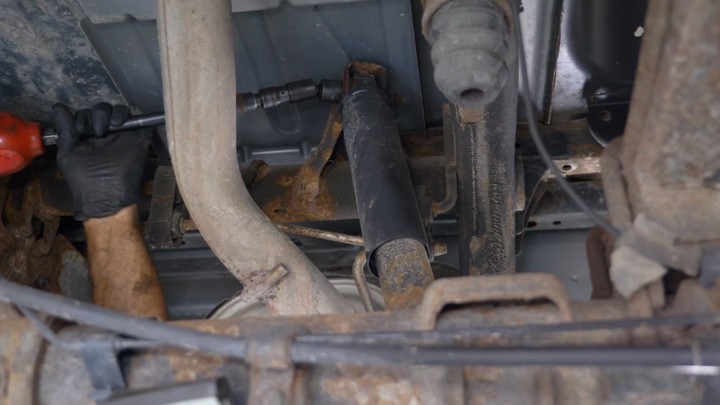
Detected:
left=456, top=93, right=517, bottom=275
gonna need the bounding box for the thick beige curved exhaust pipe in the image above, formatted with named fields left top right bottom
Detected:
left=158, top=0, right=352, bottom=315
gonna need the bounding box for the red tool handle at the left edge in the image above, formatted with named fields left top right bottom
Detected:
left=0, top=112, right=45, bottom=176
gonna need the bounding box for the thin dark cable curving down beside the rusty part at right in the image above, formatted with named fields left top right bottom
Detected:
left=511, top=0, right=620, bottom=238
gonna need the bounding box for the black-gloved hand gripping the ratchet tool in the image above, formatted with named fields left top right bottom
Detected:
left=53, top=103, right=151, bottom=221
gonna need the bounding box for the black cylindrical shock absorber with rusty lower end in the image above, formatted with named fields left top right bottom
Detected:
left=343, top=73, right=433, bottom=310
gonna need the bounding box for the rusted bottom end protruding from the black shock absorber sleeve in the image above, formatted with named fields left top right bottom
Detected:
left=375, top=239, right=434, bottom=311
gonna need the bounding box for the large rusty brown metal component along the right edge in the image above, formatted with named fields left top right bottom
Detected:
left=602, top=0, right=720, bottom=300
